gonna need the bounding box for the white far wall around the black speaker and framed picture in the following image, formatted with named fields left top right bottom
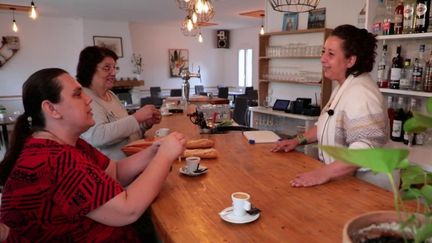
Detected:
left=126, top=23, right=258, bottom=90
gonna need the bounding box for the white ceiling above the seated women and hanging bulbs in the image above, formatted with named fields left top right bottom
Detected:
left=0, top=0, right=265, bottom=29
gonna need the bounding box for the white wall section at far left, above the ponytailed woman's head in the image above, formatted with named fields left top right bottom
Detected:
left=0, top=13, right=83, bottom=96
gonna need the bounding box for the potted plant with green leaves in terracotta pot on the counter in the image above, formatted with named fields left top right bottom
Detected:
left=320, top=98, right=432, bottom=243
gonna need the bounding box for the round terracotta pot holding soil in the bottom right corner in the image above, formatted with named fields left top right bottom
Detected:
left=342, top=211, right=422, bottom=243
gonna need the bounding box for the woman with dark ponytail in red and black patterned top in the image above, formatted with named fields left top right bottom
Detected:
left=0, top=68, right=185, bottom=242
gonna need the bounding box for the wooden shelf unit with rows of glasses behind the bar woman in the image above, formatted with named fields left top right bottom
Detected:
left=258, top=28, right=332, bottom=109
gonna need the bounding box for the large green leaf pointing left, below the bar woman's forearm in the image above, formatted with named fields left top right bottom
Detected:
left=319, top=146, right=409, bottom=173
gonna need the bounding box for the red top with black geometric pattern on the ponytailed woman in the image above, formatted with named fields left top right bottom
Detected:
left=0, top=138, right=137, bottom=242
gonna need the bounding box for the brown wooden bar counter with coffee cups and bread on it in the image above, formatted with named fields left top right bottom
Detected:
left=147, top=111, right=393, bottom=243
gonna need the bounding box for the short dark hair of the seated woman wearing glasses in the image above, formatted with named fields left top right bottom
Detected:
left=76, top=46, right=118, bottom=87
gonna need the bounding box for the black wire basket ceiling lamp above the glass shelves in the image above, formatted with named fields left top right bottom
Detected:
left=268, top=0, right=320, bottom=13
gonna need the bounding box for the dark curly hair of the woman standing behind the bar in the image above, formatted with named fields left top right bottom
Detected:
left=330, top=24, right=377, bottom=77
